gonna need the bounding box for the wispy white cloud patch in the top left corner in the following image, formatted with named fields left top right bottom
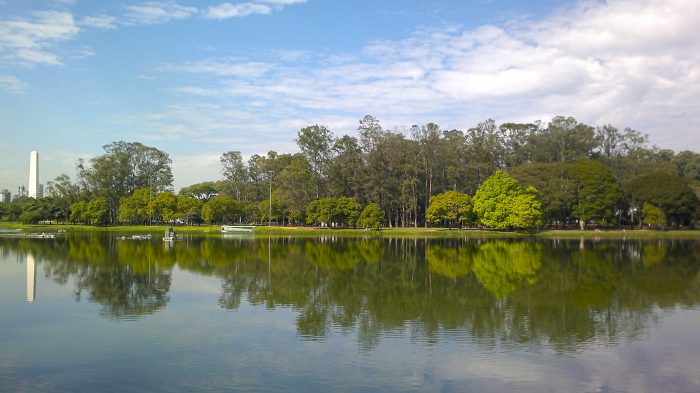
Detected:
left=0, top=11, right=80, bottom=67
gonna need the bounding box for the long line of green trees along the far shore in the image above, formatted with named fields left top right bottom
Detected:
left=0, top=116, right=700, bottom=229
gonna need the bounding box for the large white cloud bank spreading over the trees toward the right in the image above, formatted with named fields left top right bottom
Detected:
left=168, top=0, right=700, bottom=150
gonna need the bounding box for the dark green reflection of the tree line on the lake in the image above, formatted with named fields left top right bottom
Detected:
left=0, top=234, right=700, bottom=351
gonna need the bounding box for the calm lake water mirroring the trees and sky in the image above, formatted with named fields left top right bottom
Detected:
left=0, top=234, right=700, bottom=392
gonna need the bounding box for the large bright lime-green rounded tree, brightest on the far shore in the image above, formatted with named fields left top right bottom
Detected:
left=472, top=171, right=542, bottom=229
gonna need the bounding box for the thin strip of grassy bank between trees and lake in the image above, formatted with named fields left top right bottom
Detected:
left=0, top=222, right=700, bottom=239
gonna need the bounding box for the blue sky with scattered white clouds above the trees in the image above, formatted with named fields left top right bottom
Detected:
left=0, top=0, right=700, bottom=192
